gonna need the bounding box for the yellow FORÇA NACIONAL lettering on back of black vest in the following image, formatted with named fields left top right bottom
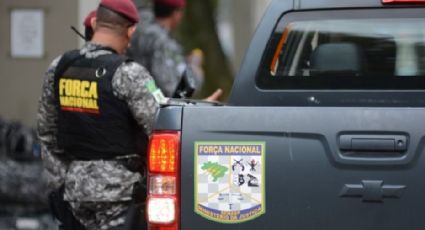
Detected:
left=59, top=78, right=99, bottom=112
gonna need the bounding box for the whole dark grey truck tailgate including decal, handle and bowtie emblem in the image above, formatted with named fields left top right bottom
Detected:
left=180, top=107, right=425, bottom=230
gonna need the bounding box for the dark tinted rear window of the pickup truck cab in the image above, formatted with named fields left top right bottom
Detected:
left=257, top=8, right=425, bottom=90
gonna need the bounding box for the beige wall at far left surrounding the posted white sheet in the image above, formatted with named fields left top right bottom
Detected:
left=0, top=0, right=78, bottom=125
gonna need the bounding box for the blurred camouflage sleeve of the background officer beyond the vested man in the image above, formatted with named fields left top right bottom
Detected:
left=151, top=39, right=186, bottom=97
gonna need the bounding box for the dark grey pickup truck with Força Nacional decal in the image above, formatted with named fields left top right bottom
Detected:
left=146, top=0, right=425, bottom=230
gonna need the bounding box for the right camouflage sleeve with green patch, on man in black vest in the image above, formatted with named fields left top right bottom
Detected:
left=112, top=62, right=167, bottom=135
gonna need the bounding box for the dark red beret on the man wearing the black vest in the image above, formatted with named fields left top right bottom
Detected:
left=100, top=0, right=140, bottom=23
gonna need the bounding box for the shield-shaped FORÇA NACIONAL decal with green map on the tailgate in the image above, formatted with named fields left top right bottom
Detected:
left=195, top=142, right=266, bottom=224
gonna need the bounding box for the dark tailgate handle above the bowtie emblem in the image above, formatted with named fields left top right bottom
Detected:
left=339, top=135, right=407, bottom=152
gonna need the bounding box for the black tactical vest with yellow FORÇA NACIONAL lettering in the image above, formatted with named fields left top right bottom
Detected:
left=54, top=50, right=139, bottom=160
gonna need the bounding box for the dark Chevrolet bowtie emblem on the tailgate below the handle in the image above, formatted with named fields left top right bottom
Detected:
left=340, top=180, right=406, bottom=202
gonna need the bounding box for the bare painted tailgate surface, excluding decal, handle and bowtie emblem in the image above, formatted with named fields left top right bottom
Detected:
left=177, top=107, right=425, bottom=230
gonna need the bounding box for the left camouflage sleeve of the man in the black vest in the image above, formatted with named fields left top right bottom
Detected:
left=37, top=57, right=68, bottom=189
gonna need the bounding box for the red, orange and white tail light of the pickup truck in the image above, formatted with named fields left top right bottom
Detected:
left=146, top=132, right=180, bottom=230
